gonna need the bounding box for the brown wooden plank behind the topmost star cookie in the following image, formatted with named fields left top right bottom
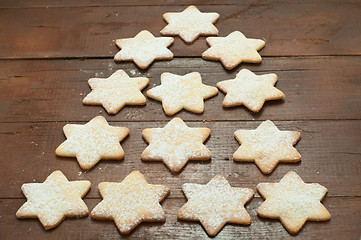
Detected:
left=0, top=1, right=361, bottom=59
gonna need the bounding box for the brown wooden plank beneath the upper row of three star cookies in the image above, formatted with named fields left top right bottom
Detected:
left=0, top=57, right=361, bottom=122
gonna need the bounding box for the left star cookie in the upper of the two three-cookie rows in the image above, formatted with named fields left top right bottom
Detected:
left=83, top=70, right=149, bottom=114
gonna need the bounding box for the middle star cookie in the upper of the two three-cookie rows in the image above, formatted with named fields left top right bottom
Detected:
left=147, top=72, right=218, bottom=116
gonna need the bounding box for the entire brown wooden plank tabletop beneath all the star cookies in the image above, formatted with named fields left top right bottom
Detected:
left=0, top=0, right=361, bottom=240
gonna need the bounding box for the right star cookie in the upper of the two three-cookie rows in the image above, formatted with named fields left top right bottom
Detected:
left=217, top=69, right=285, bottom=112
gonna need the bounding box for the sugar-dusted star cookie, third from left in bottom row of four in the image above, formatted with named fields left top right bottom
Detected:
left=177, top=175, right=254, bottom=236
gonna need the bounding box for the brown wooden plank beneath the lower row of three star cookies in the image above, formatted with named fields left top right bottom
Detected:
left=0, top=120, right=361, bottom=198
